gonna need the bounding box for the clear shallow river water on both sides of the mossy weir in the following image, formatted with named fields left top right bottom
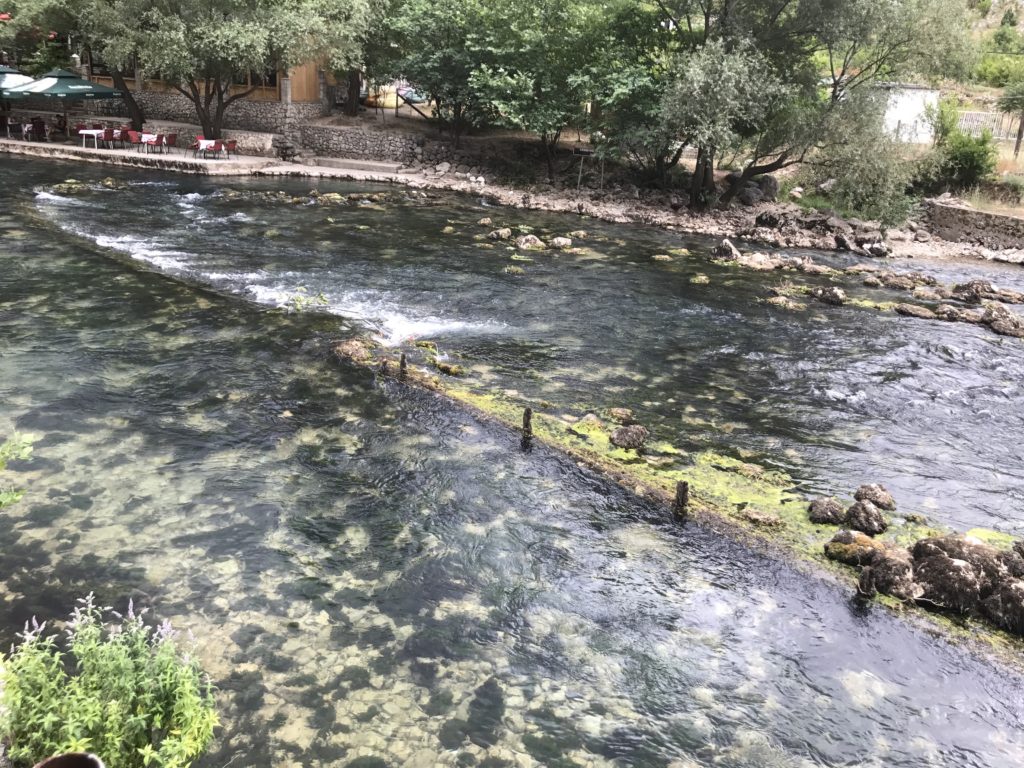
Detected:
left=0, top=159, right=1024, bottom=768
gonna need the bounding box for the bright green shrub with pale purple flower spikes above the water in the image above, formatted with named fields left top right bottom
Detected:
left=0, top=595, right=217, bottom=768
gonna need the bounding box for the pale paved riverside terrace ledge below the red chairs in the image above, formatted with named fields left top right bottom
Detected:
left=0, top=138, right=276, bottom=176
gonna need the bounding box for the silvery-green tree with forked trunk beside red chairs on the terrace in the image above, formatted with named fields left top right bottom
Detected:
left=89, top=0, right=371, bottom=138
